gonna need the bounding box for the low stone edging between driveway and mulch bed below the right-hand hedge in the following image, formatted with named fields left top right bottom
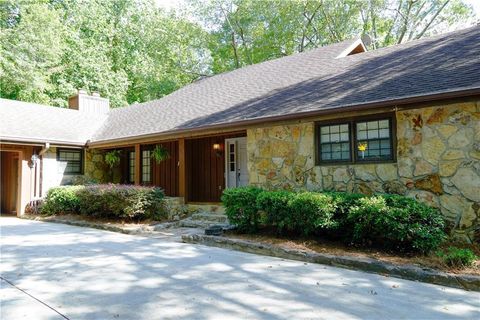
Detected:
left=182, top=234, right=480, bottom=292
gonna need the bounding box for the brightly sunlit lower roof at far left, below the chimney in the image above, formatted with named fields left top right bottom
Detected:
left=0, top=99, right=107, bottom=146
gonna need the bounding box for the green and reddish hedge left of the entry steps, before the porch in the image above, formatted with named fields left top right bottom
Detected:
left=41, top=184, right=166, bottom=220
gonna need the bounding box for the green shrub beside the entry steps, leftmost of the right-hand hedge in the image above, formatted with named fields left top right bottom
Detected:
left=222, top=187, right=263, bottom=233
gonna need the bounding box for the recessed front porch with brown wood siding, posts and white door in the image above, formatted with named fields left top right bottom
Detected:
left=103, top=131, right=248, bottom=204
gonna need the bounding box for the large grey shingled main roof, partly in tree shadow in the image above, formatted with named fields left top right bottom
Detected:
left=92, top=26, right=480, bottom=143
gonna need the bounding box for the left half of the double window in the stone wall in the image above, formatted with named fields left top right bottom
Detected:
left=320, top=123, right=350, bottom=161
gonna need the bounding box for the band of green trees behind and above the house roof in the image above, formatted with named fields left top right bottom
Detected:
left=0, top=0, right=475, bottom=107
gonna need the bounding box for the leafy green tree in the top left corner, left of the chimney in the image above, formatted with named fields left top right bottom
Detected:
left=0, top=2, right=66, bottom=104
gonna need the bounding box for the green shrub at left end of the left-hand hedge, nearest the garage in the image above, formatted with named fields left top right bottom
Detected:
left=40, top=186, right=84, bottom=215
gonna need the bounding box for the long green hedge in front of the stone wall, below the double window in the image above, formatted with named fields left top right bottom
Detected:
left=222, top=187, right=446, bottom=253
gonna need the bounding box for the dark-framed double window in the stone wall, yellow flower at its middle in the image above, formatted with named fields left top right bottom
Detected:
left=316, top=117, right=394, bottom=163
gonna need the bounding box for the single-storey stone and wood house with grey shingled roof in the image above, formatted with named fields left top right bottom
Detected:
left=0, top=26, right=480, bottom=241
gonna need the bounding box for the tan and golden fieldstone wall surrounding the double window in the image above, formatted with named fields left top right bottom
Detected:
left=247, top=102, right=480, bottom=241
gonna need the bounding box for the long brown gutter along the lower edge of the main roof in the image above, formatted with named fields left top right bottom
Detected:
left=87, top=87, right=480, bottom=148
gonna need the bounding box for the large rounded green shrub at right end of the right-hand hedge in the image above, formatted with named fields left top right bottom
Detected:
left=347, top=195, right=446, bottom=253
